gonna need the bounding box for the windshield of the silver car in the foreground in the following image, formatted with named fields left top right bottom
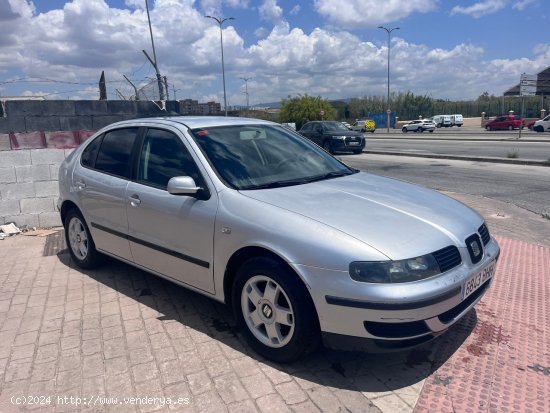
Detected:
left=191, top=125, right=358, bottom=190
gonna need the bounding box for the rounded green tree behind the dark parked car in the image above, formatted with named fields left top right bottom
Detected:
left=279, top=94, right=335, bottom=129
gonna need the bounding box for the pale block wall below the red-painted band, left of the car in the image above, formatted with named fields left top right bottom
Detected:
left=0, top=149, right=73, bottom=227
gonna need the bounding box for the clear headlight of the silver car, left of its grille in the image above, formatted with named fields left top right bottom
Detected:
left=349, top=254, right=441, bottom=283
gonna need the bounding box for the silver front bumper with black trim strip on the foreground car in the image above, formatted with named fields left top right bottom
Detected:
left=297, top=239, right=500, bottom=349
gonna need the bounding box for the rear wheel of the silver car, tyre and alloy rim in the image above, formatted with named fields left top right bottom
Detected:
left=63, top=209, right=102, bottom=269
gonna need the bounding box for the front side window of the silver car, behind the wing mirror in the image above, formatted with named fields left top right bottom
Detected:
left=137, top=129, right=201, bottom=189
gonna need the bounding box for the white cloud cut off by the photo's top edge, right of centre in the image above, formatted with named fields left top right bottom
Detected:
left=314, top=0, right=439, bottom=29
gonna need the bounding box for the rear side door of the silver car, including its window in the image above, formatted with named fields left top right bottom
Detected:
left=73, top=127, right=138, bottom=260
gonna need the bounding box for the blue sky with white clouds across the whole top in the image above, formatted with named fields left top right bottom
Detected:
left=0, top=0, right=550, bottom=105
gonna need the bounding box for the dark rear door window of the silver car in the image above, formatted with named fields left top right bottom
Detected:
left=95, top=128, right=138, bottom=177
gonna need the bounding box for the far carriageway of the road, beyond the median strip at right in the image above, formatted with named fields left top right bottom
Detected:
left=365, top=136, right=550, bottom=161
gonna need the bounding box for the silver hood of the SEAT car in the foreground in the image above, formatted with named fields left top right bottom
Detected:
left=241, top=172, right=483, bottom=259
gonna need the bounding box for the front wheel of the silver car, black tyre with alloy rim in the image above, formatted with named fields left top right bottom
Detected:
left=232, top=257, right=321, bottom=363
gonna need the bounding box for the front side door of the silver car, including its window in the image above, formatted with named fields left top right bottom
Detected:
left=126, top=128, right=218, bottom=293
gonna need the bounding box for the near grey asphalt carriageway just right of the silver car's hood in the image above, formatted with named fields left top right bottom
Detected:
left=338, top=152, right=550, bottom=216
